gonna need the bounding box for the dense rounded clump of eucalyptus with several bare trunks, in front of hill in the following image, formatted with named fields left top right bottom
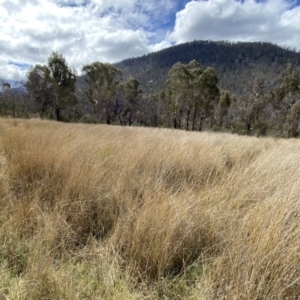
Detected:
left=162, top=60, right=219, bottom=130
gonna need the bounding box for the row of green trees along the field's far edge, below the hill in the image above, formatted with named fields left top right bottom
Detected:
left=0, top=47, right=300, bottom=137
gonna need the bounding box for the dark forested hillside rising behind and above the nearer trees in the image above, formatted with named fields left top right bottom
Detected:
left=116, top=41, right=300, bottom=97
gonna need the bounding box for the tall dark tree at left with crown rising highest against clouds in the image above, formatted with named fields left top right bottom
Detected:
left=48, top=52, right=77, bottom=121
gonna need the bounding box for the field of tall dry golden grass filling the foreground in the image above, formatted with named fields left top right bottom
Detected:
left=0, top=119, right=300, bottom=300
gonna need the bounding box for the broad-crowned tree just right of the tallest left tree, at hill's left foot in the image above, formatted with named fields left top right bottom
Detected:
left=82, top=61, right=122, bottom=124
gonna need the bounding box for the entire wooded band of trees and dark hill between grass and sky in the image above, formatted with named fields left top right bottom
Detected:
left=0, top=41, right=300, bottom=137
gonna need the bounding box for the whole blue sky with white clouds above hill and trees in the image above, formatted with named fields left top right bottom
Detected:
left=0, top=0, right=300, bottom=82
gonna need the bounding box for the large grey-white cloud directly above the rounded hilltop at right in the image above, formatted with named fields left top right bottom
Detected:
left=166, top=0, right=300, bottom=49
